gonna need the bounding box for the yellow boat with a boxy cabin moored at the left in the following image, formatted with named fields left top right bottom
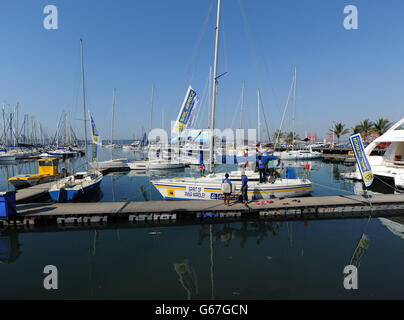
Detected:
left=8, top=158, right=62, bottom=189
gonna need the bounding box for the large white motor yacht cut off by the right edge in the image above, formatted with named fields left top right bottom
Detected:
left=343, top=118, right=404, bottom=188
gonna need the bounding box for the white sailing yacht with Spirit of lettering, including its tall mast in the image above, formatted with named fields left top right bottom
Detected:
left=151, top=0, right=313, bottom=200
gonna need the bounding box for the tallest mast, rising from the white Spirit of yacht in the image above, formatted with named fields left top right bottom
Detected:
left=209, top=0, right=221, bottom=173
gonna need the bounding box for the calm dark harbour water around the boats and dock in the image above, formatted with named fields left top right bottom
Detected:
left=0, top=151, right=404, bottom=299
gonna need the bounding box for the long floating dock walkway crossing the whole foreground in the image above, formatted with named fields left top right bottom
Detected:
left=0, top=194, right=404, bottom=225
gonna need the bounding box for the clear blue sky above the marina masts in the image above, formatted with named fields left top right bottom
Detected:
left=0, top=0, right=404, bottom=139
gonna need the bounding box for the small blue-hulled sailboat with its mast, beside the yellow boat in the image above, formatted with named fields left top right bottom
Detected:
left=48, top=39, right=103, bottom=202
